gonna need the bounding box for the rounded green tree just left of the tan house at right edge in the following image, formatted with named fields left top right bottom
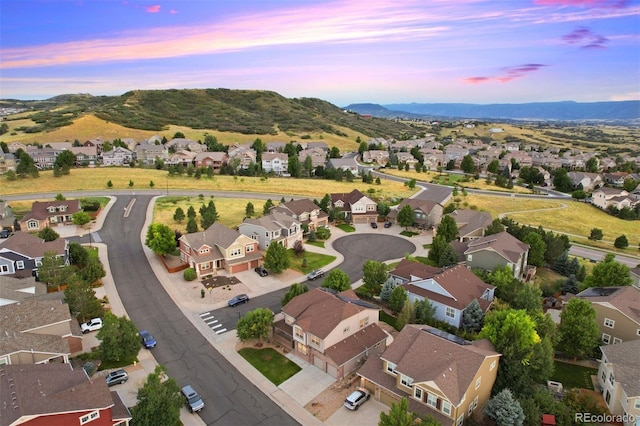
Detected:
left=559, top=297, right=600, bottom=358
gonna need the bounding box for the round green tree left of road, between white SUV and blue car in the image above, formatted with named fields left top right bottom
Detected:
left=96, top=311, right=140, bottom=362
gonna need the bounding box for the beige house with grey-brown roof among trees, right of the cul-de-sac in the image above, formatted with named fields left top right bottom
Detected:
left=464, top=231, right=529, bottom=279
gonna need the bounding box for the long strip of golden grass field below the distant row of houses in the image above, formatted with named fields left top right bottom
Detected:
left=0, top=167, right=417, bottom=201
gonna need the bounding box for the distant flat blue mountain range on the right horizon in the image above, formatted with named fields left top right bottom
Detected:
left=344, top=100, right=640, bottom=121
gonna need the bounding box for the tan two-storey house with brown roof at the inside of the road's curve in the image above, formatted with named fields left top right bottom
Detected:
left=179, top=222, right=262, bottom=278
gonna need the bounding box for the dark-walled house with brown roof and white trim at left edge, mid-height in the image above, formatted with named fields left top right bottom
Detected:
left=0, top=231, right=69, bottom=278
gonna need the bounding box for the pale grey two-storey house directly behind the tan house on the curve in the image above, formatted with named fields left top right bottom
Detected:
left=238, top=211, right=302, bottom=250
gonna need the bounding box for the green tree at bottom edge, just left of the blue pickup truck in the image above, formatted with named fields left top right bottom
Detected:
left=131, top=365, right=184, bottom=426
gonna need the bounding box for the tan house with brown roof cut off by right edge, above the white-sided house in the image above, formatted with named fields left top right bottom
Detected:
left=576, top=286, right=640, bottom=345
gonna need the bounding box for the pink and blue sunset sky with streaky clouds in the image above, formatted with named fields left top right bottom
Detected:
left=0, top=0, right=640, bottom=106
